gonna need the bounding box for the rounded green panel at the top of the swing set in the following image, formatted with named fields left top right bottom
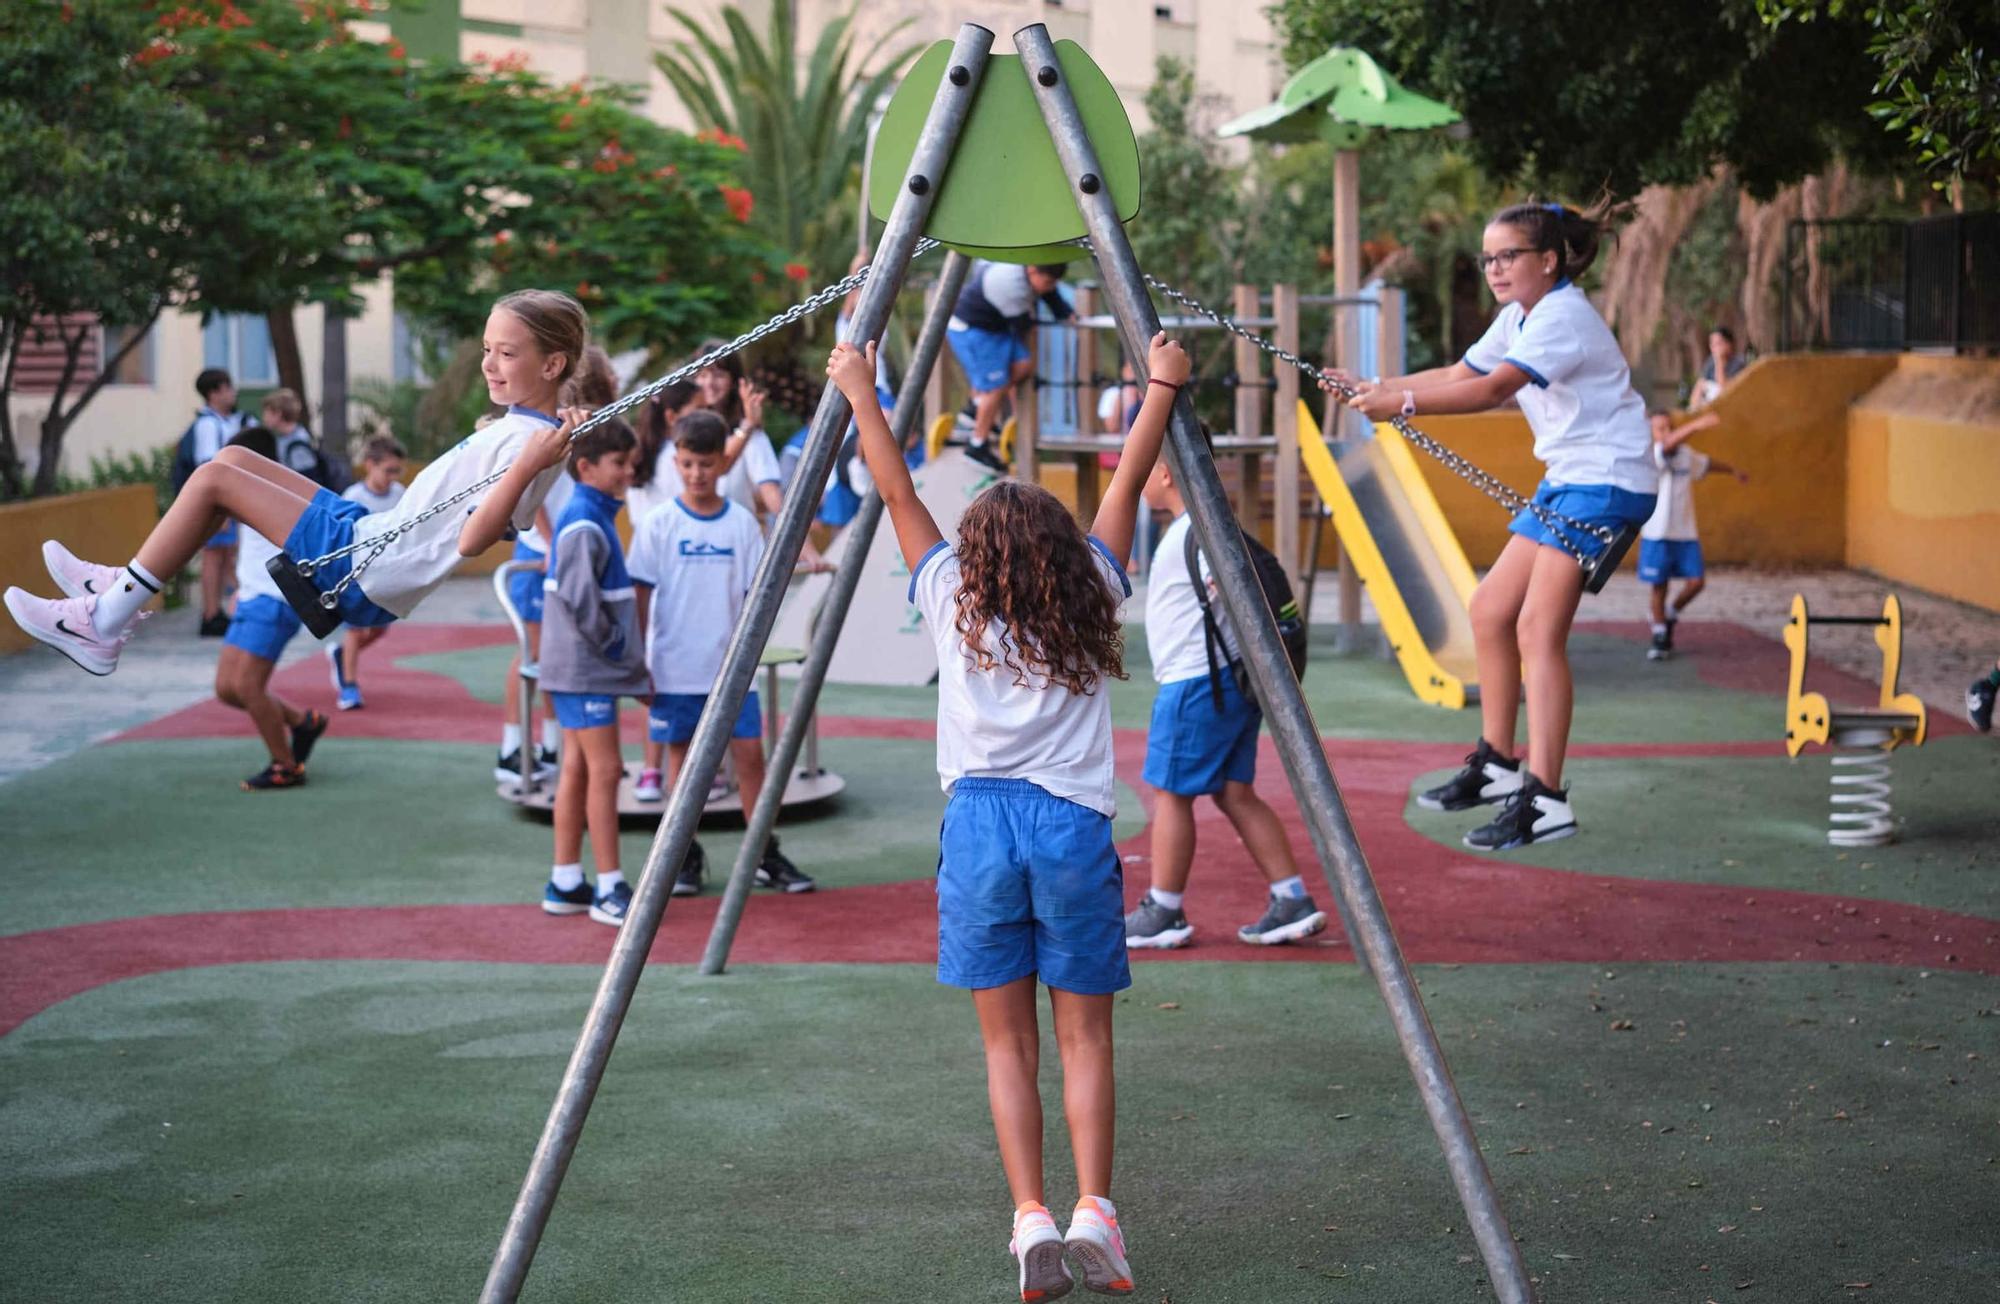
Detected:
left=868, top=40, right=1140, bottom=250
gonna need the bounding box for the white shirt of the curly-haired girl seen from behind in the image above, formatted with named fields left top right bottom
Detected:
left=910, top=538, right=1132, bottom=816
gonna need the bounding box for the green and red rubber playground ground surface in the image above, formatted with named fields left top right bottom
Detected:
left=0, top=624, right=2000, bottom=1304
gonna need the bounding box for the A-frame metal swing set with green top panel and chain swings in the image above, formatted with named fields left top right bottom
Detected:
left=258, top=24, right=1632, bottom=1304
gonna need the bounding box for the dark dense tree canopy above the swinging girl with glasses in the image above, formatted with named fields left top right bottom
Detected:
left=1270, top=0, right=1892, bottom=204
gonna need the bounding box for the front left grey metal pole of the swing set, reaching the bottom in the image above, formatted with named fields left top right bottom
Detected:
left=480, top=22, right=994, bottom=1304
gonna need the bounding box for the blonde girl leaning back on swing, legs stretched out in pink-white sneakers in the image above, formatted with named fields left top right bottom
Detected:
left=6, top=290, right=590, bottom=674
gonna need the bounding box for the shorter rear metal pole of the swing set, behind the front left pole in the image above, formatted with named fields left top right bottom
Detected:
left=702, top=250, right=972, bottom=976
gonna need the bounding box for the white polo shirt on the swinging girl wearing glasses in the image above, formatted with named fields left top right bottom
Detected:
left=1464, top=280, right=1660, bottom=494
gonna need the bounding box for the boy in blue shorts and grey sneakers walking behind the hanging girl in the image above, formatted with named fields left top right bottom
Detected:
left=1126, top=446, right=1326, bottom=950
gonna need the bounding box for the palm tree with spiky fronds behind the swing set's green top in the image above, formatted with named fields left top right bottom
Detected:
left=654, top=0, right=920, bottom=284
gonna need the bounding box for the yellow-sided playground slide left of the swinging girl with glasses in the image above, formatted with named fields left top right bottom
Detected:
left=1298, top=400, right=1480, bottom=710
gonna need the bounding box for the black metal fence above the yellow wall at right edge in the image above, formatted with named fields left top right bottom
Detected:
left=1778, top=212, right=2000, bottom=352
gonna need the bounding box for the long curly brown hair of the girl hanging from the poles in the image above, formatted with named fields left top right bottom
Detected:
left=956, top=480, right=1126, bottom=694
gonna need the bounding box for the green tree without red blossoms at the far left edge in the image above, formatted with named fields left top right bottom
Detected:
left=0, top=0, right=254, bottom=498
